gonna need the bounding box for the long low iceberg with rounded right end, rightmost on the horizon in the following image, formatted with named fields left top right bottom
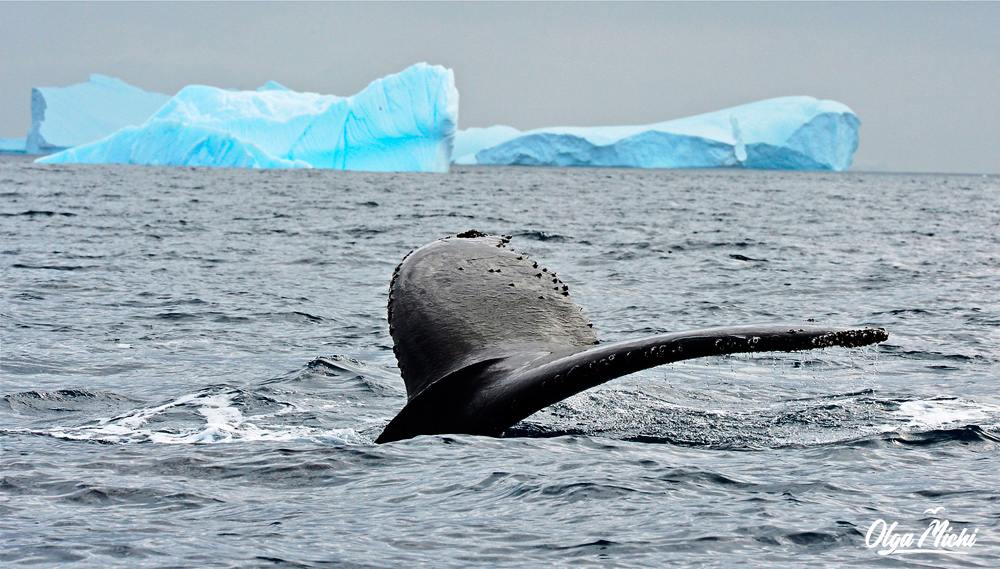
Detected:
left=455, top=97, right=861, bottom=170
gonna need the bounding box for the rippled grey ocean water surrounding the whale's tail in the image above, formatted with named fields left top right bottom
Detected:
left=0, top=154, right=1000, bottom=567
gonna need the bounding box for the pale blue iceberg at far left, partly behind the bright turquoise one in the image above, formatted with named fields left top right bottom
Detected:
left=26, top=73, right=170, bottom=154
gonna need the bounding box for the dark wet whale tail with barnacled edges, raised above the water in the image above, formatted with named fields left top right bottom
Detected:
left=375, top=230, right=889, bottom=443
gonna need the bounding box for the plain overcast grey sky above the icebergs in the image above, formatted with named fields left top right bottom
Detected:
left=0, top=1, right=1000, bottom=173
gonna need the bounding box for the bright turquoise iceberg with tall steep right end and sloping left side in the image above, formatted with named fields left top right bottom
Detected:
left=38, top=63, right=458, bottom=172
